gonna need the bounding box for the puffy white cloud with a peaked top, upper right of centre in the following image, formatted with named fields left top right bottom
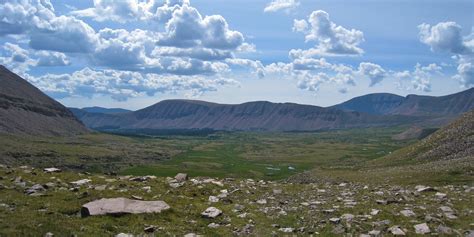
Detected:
left=290, top=10, right=364, bottom=57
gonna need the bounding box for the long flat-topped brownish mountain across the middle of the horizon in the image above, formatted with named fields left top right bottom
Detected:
left=73, top=100, right=418, bottom=131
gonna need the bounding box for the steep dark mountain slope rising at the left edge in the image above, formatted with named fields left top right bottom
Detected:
left=0, top=65, right=87, bottom=135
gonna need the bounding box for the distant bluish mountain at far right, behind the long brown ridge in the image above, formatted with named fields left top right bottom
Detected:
left=333, top=88, right=474, bottom=117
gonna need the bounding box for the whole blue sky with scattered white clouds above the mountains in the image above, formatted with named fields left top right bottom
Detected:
left=0, top=0, right=474, bottom=109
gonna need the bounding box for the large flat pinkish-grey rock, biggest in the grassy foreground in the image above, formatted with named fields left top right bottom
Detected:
left=81, top=198, right=170, bottom=217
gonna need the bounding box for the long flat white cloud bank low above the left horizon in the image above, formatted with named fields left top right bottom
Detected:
left=27, top=68, right=238, bottom=101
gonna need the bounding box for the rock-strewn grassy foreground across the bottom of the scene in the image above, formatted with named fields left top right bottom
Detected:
left=0, top=166, right=474, bottom=236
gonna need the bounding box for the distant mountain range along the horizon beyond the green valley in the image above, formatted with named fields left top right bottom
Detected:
left=72, top=89, right=474, bottom=131
